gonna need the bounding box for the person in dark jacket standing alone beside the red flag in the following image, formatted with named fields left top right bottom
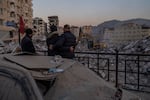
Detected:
left=21, top=28, right=35, bottom=53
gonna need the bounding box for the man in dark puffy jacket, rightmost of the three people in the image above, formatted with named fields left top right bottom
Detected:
left=54, top=24, right=76, bottom=59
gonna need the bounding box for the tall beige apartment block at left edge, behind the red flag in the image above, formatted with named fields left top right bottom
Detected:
left=0, top=0, right=33, bottom=40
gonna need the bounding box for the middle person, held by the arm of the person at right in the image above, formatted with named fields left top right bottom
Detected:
left=46, top=25, right=59, bottom=56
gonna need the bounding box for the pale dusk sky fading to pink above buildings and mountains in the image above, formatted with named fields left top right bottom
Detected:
left=33, top=0, right=150, bottom=26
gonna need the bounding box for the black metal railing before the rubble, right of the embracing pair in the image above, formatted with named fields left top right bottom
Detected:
left=76, top=51, right=150, bottom=92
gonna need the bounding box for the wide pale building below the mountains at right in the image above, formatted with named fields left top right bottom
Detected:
left=104, top=23, right=150, bottom=46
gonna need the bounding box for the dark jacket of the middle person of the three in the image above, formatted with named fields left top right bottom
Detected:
left=46, top=31, right=59, bottom=56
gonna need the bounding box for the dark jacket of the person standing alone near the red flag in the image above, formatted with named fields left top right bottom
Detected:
left=21, top=35, right=35, bottom=53
